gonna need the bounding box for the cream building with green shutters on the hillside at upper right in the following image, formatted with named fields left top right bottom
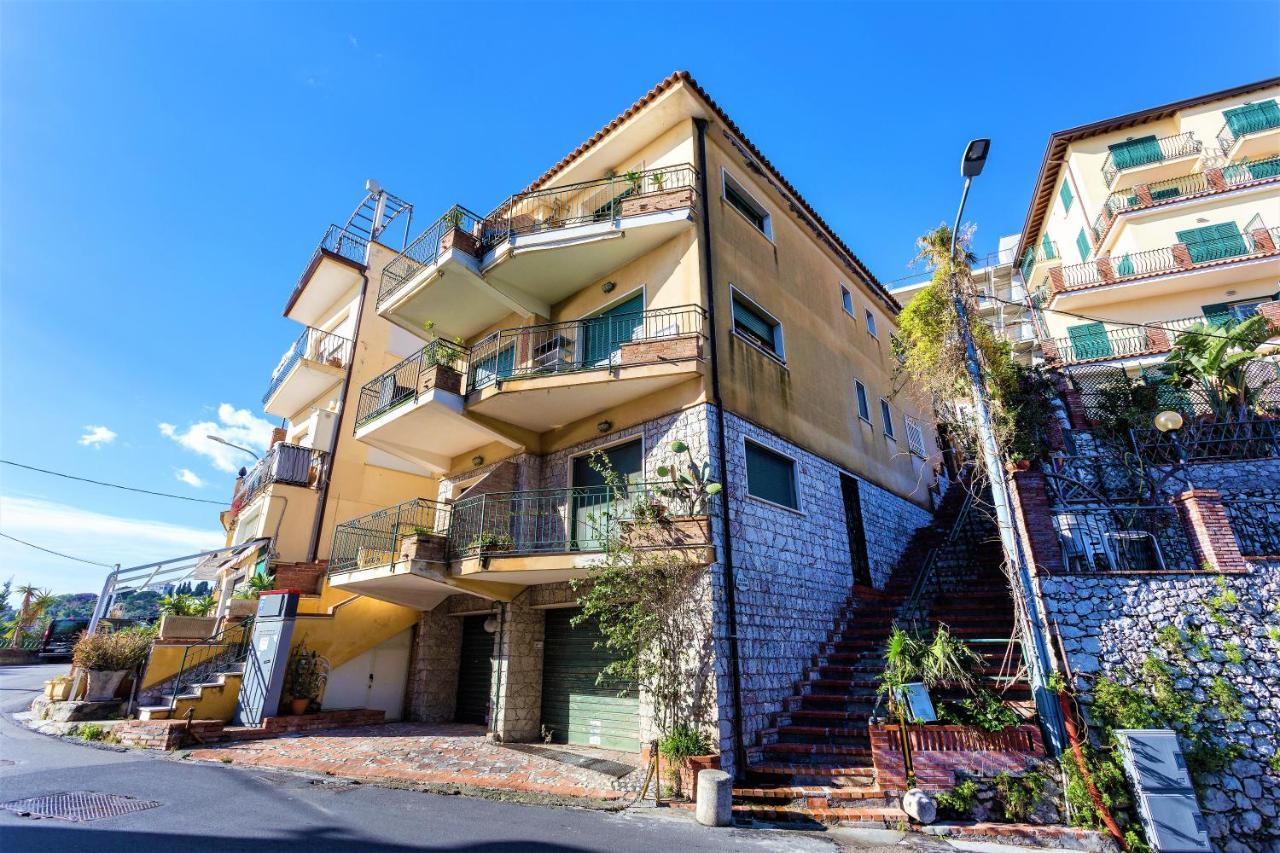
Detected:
left=1018, top=78, right=1280, bottom=374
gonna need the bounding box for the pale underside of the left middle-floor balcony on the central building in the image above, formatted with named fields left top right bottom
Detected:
left=356, top=388, right=520, bottom=474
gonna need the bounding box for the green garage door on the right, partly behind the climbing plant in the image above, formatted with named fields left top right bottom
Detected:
left=543, top=608, right=640, bottom=752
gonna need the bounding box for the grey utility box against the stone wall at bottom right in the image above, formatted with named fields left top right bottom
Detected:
left=1115, top=729, right=1213, bottom=853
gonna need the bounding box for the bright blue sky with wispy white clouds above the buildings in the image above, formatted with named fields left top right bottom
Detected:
left=0, top=3, right=1280, bottom=592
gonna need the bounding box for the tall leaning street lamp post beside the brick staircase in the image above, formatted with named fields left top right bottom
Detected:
left=947, top=140, right=1064, bottom=754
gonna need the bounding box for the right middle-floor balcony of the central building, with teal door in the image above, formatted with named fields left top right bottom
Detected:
left=467, top=305, right=707, bottom=433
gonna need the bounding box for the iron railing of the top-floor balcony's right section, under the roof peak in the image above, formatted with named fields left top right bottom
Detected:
left=481, top=164, right=698, bottom=247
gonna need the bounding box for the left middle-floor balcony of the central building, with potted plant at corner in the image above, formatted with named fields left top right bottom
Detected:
left=356, top=339, right=518, bottom=474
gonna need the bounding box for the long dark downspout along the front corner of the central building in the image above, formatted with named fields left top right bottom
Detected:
left=694, top=119, right=746, bottom=779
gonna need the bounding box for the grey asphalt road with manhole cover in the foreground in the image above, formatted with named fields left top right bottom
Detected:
left=0, top=666, right=926, bottom=853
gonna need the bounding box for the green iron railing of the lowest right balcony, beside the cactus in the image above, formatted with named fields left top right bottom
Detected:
left=449, top=483, right=717, bottom=558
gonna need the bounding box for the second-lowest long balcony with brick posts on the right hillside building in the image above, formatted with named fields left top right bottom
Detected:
left=1050, top=228, right=1280, bottom=306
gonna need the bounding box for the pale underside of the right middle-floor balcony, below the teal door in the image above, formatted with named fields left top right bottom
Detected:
left=467, top=359, right=704, bottom=433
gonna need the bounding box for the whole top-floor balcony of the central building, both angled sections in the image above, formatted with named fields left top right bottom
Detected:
left=378, top=165, right=698, bottom=338
